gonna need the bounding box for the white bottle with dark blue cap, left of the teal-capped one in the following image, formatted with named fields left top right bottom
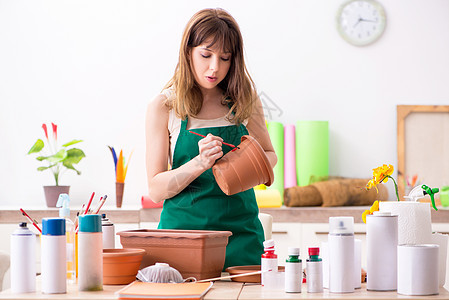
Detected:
left=41, top=218, right=67, bottom=294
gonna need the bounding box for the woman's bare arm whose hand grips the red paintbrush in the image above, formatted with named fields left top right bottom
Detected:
left=145, top=94, right=223, bottom=202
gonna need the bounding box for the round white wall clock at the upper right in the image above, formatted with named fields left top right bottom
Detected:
left=337, top=0, right=385, bottom=46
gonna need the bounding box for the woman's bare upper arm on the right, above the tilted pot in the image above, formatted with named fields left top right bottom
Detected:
left=246, top=97, right=278, bottom=168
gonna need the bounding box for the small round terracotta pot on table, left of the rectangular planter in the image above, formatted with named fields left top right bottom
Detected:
left=103, top=248, right=145, bottom=284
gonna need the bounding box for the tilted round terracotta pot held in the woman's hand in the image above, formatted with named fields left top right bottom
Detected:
left=212, top=135, right=274, bottom=195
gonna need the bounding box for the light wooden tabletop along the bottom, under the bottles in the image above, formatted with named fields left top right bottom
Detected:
left=0, top=280, right=449, bottom=300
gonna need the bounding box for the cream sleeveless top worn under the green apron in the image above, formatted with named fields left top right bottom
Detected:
left=162, top=88, right=248, bottom=165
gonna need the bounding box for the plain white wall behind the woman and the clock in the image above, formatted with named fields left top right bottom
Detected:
left=0, top=0, right=449, bottom=207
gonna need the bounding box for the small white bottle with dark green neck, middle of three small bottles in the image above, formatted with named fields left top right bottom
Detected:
left=285, top=247, right=302, bottom=293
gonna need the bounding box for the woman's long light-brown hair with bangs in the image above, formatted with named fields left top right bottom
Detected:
left=164, top=8, right=257, bottom=124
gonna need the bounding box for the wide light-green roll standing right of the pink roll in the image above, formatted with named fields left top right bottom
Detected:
left=296, top=121, right=329, bottom=186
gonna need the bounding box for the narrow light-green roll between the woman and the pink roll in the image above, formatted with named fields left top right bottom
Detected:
left=267, top=122, right=284, bottom=199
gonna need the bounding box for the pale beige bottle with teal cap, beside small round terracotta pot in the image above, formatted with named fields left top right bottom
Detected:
left=78, top=215, right=103, bottom=291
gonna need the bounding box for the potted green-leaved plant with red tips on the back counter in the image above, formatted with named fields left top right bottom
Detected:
left=28, top=123, right=86, bottom=207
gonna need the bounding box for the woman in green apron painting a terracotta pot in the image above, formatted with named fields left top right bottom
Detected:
left=146, top=9, right=277, bottom=268
